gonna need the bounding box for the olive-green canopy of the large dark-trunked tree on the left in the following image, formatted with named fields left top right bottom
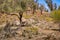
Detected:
left=0, top=0, right=25, bottom=12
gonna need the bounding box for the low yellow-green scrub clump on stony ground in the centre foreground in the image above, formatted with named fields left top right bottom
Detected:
left=22, top=27, right=39, bottom=39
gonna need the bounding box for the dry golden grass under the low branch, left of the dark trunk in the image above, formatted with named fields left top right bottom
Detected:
left=0, top=13, right=19, bottom=24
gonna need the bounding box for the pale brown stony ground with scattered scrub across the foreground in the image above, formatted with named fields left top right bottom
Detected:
left=0, top=13, right=60, bottom=40
